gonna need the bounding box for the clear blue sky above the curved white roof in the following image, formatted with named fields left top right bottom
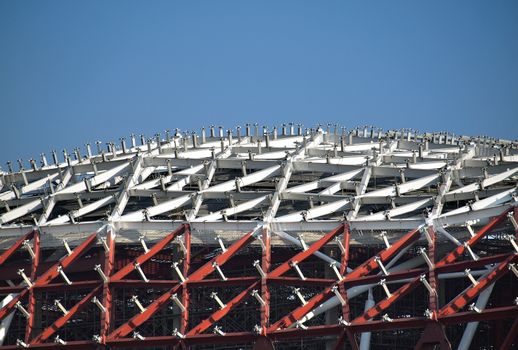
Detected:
left=0, top=0, right=518, bottom=169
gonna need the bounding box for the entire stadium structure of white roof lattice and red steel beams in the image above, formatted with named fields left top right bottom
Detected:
left=0, top=124, right=518, bottom=349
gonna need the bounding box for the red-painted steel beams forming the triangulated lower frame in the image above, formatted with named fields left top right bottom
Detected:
left=0, top=209, right=518, bottom=349
